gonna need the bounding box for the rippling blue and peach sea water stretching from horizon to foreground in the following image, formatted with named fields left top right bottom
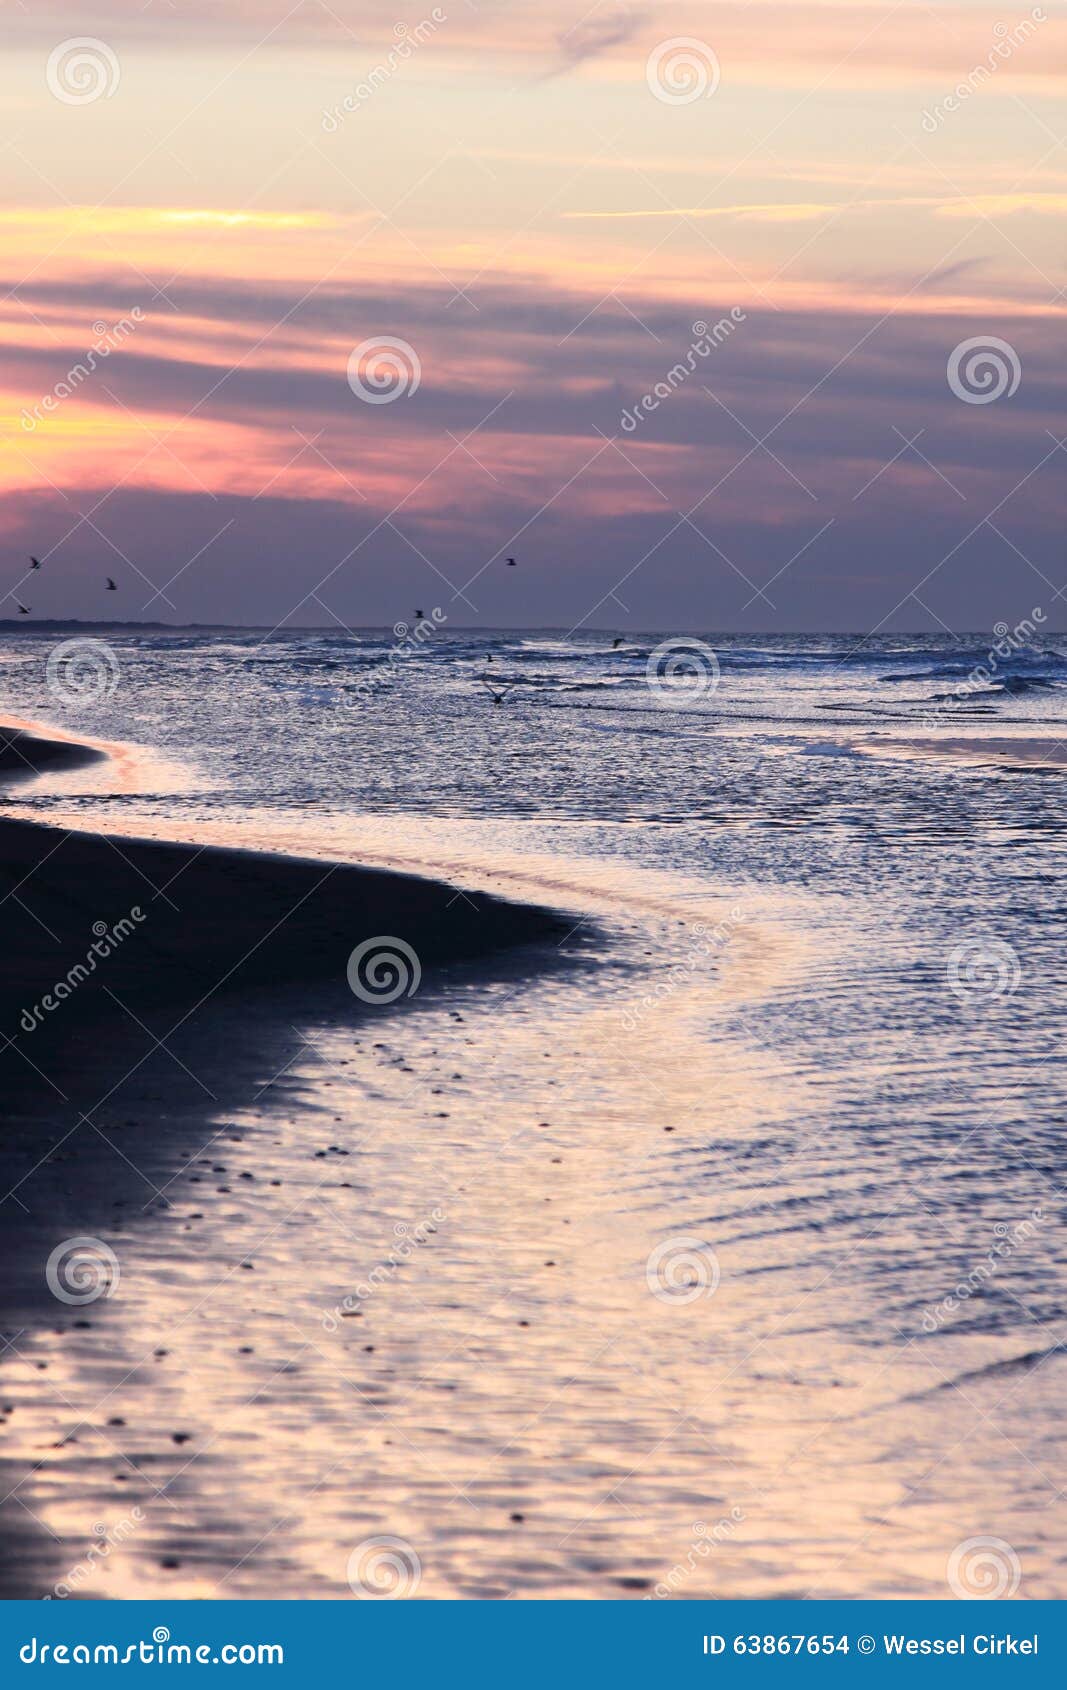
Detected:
left=2, top=630, right=1067, bottom=1597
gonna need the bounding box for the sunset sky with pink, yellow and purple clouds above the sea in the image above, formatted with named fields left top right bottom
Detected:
left=0, top=0, right=1067, bottom=635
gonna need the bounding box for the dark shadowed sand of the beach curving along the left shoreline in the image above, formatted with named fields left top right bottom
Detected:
left=0, top=728, right=565, bottom=1595
